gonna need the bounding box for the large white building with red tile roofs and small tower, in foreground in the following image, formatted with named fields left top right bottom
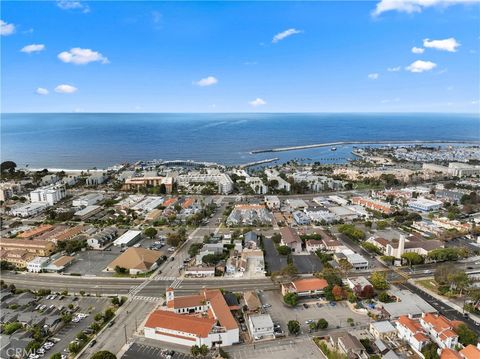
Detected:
left=144, top=288, right=240, bottom=348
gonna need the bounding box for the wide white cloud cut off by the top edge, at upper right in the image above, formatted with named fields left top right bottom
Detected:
left=372, top=0, right=478, bottom=16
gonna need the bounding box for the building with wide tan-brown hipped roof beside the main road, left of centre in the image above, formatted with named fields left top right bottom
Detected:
left=106, top=248, right=162, bottom=274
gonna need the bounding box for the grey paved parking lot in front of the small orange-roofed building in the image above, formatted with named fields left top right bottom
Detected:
left=259, top=291, right=369, bottom=333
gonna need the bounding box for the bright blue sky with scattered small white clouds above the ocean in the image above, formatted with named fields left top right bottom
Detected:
left=0, top=0, right=480, bottom=113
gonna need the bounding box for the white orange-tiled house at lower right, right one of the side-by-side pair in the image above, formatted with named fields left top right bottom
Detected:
left=420, top=313, right=458, bottom=349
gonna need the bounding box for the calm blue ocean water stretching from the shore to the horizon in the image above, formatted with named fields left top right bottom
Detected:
left=1, top=113, right=480, bottom=169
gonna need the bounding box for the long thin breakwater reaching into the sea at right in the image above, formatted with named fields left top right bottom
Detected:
left=250, top=140, right=480, bottom=155
